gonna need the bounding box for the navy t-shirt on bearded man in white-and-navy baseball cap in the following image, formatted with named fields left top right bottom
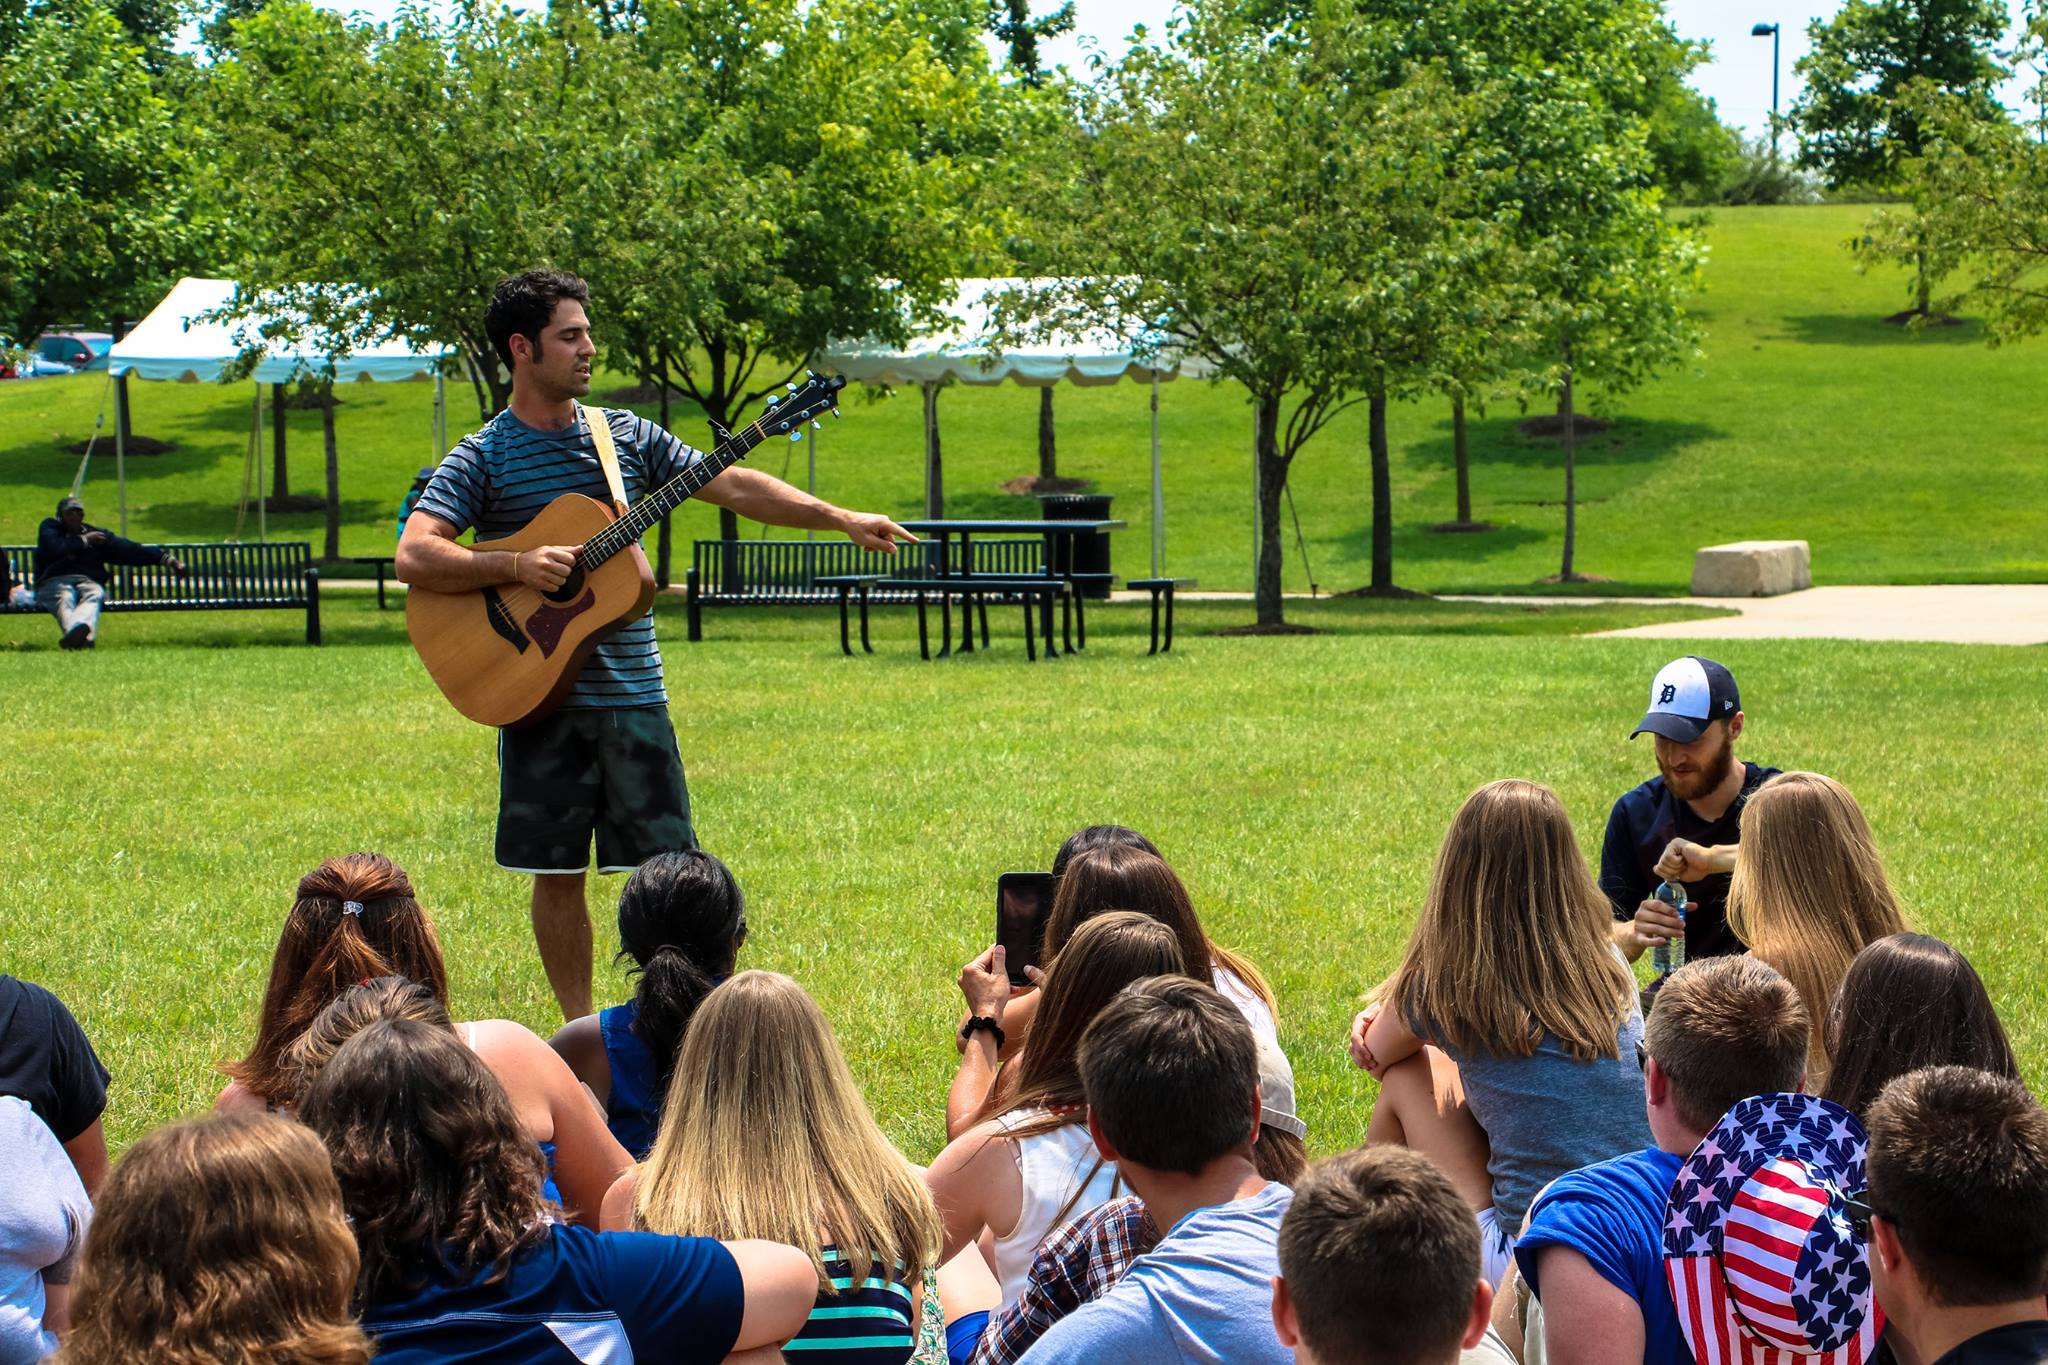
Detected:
left=1599, top=763, right=1778, bottom=962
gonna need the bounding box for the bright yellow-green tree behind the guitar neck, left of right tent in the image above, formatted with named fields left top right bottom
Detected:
left=578, top=0, right=1006, bottom=552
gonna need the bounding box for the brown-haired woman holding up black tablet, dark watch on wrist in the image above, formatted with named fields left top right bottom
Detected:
left=946, top=843, right=1278, bottom=1138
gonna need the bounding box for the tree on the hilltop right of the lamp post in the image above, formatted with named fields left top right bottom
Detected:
left=1790, top=0, right=2007, bottom=317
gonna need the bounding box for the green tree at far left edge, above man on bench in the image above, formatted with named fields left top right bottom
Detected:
left=0, top=0, right=199, bottom=340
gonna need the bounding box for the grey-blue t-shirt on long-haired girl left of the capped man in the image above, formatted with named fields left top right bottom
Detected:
left=1409, top=999, right=1651, bottom=1236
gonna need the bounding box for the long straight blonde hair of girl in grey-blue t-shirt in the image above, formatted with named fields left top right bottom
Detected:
left=1376, top=778, right=1636, bottom=1062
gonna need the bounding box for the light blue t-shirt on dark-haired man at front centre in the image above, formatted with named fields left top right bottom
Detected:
left=1024, top=1185, right=1294, bottom=1365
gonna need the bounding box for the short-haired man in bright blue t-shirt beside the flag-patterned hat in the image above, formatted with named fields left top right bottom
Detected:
left=1501, top=958, right=1808, bottom=1365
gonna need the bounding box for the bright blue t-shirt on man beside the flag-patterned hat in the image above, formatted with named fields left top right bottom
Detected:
left=1516, top=1148, right=1692, bottom=1365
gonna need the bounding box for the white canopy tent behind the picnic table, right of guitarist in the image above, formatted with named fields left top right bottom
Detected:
left=817, top=278, right=1212, bottom=577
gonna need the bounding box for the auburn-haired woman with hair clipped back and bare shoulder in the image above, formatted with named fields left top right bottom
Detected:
left=213, top=853, right=633, bottom=1228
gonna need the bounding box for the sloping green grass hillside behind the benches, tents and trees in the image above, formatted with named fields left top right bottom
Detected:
left=0, top=205, right=2048, bottom=593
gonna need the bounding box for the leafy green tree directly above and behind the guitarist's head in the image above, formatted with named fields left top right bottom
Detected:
left=207, top=0, right=630, bottom=417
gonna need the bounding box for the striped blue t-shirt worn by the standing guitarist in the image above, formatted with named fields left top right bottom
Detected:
left=416, top=407, right=705, bottom=708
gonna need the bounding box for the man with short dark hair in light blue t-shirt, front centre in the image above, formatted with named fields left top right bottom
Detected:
left=1024, top=976, right=1294, bottom=1365
